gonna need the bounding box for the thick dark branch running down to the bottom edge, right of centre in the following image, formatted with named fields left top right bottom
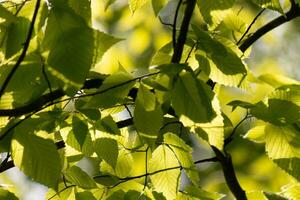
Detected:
left=211, top=146, right=247, bottom=200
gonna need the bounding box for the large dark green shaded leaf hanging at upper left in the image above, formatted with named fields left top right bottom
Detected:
left=47, top=27, right=94, bottom=87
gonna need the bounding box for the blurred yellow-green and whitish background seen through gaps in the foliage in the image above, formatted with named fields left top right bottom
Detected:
left=0, top=0, right=300, bottom=200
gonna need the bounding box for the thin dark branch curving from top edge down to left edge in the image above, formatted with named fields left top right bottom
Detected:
left=0, top=0, right=41, bottom=99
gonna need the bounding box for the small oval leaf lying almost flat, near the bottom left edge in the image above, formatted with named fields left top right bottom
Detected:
left=66, top=166, right=97, bottom=189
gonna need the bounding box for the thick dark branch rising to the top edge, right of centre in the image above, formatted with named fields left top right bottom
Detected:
left=171, top=0, right=196, bottom=63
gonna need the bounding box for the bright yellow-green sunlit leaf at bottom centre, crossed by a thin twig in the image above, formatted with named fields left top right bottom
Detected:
left=149, top=145, right=181, bottom=199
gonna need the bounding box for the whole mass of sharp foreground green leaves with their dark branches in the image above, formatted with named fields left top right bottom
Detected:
left=0, top=0, right=300, bottom=200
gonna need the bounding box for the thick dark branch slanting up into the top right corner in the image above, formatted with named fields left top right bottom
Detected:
left=239, top=4, right=300, bottom=52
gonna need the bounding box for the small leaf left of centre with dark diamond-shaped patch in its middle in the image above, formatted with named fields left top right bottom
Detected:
left=66, top=116, right=94, bottom=156
